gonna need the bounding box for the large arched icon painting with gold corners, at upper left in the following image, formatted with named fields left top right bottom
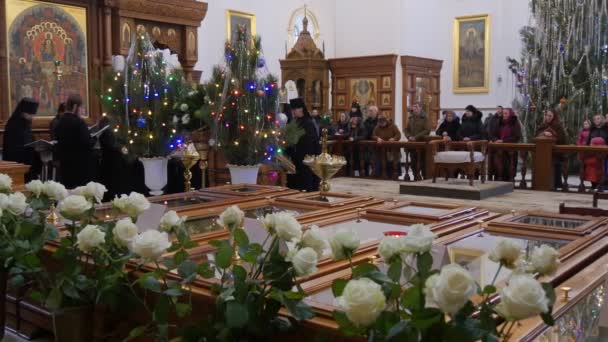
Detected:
left=5, top=0, right=89, bottom=118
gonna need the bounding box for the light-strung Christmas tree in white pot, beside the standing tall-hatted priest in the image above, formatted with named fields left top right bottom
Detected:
left=206, top=26, right=288, bottom=165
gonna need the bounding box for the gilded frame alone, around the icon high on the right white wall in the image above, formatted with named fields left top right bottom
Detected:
left=453, top=14, right=490, bottom=94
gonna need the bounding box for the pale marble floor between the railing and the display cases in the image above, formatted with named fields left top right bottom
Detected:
left=330, top=177, right=608, bottom=213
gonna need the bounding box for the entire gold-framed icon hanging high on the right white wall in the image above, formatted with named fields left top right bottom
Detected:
left=453, top=14, right=490, bottom=93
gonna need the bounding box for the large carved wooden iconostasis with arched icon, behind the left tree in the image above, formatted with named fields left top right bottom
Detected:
left=0, top=0, right=207, bottom=142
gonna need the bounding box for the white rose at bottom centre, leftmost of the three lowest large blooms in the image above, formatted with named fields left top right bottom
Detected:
left=336, top=278, right=386, bottom=326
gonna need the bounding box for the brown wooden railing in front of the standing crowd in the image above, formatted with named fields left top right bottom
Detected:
left=329, top=137, right=608, bottom=192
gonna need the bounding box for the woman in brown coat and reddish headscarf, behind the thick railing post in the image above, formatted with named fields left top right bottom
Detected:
left=535, top=109, right=568, bottom=190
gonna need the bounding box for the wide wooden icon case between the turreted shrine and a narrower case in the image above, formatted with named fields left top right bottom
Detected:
left=329, top=55, right=397, bottom=120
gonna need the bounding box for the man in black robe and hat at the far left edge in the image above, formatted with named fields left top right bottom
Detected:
left=2, top=97, right=42, bottom=181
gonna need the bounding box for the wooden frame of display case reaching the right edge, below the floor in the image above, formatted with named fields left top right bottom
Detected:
left=488, top=211, right=608, bottom=236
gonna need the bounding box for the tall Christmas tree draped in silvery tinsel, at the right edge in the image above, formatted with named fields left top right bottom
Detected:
left=508, top=0, right=608, bottom=138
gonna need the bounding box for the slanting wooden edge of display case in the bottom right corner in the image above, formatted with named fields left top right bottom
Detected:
left=506, top=244, right=608, bottom=342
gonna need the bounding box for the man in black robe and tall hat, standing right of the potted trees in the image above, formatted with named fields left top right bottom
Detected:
left=287, top=98, right=321, bottom=192
